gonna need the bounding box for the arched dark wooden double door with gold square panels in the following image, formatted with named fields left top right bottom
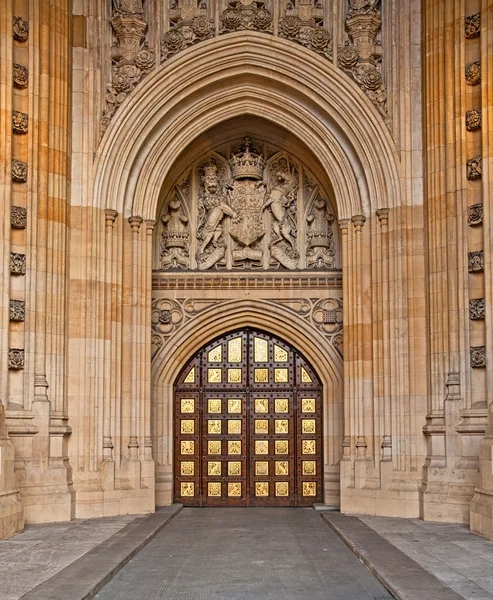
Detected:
left=174, top=329, right=322, bottom=506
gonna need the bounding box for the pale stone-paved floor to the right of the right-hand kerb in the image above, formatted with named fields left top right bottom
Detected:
left=358, top=517, right=493, bottom=600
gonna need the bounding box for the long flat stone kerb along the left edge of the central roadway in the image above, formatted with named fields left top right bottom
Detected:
left=21, top=504, right=183, bottom=600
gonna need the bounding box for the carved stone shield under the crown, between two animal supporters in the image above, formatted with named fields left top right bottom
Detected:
left=230, top=179, right=265, bottom=246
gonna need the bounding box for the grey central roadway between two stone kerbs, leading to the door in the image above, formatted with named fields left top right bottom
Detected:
left=95, top=508, right=392, bottom=600
